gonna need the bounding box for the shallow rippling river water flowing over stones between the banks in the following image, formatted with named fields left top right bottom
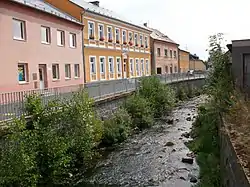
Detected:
left=79, top=96, right=205, bottom=187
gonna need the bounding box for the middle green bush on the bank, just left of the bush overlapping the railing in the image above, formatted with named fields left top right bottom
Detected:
left=125, top=95, right=154, bottom=129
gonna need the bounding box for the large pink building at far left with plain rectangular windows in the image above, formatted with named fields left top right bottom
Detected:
left=0, top=0, right=84, bottom=93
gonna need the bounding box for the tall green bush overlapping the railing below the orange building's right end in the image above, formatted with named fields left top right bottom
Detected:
left=139, top=76, right=175, bottom=117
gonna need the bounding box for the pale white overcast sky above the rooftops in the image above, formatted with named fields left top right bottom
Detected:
left=79, top=0, right=250, bottom=60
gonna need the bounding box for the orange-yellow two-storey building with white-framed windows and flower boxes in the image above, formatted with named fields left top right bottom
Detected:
left=46, top=0, right=151, bottom=82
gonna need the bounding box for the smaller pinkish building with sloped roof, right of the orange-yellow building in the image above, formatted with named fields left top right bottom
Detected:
left=144, top=24, right=179, bottom=74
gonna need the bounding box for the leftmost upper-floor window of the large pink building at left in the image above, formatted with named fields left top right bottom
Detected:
left=13, top=19, right=26, bottom=40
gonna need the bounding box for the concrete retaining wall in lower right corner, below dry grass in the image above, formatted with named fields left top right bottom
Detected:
left=219, top=121, right=250, bottom=187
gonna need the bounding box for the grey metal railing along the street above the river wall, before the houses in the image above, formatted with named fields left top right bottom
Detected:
left=0, top=73, right=206, bottom=122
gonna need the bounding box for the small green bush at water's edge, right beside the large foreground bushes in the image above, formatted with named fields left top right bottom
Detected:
left=102, top=109, right=132, bottom=145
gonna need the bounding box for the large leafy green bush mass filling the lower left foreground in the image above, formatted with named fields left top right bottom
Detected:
left=0, top=91, right=103, bottom=186
